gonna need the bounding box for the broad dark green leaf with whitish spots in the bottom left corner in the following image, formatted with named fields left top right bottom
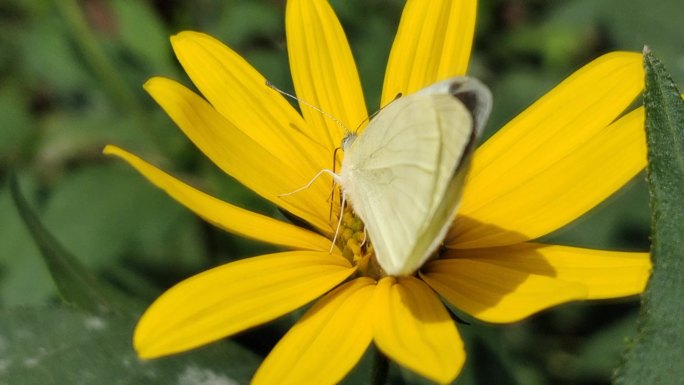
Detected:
left=0, top=308, right=260, bottom=385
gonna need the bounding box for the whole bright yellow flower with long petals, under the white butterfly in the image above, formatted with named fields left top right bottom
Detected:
left=105, top=0, right=651, bottom=384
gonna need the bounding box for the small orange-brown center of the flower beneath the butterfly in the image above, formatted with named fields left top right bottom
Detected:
left=336, top=206, right=387, bottom=279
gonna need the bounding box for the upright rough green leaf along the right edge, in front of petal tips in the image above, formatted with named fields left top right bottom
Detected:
left=615, top=50, right=684, bottom=385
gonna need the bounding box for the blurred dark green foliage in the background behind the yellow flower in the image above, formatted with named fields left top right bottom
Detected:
left=0, top=0, right=684, bottom=384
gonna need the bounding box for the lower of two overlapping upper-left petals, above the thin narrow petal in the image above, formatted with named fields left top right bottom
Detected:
left=145, top=78, right=331, bottom=233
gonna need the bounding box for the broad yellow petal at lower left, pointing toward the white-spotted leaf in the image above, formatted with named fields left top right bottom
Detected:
left=133, top=251, right=355, bottom=358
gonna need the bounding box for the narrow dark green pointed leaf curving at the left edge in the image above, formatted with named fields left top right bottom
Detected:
left=10, top=175, right=137, bottom=314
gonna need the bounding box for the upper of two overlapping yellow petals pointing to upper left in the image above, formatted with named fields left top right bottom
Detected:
left=171, top=31, right=332, bottom=174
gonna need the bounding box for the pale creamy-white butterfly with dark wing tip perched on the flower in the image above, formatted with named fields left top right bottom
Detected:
left=334, top=77, right=492, bottom=276
